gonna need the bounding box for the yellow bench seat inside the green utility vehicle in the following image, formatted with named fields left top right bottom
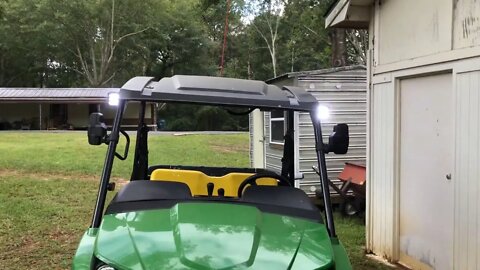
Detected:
left=150, top=169, right=277, bottom=197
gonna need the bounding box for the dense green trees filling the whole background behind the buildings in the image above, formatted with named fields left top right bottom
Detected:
left=0, top=0, right=367, bottom=130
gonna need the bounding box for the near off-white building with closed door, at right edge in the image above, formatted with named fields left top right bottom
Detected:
left=326, top=0, right=480, bottom=270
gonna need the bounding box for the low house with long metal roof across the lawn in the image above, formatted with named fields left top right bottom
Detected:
left=0, top=88, right=156, bottom=130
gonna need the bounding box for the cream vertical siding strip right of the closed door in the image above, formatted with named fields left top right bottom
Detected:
left=453, top=71, right=480, bottom=269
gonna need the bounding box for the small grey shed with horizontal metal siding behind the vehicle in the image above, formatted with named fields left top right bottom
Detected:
left=250, top=66, right=367, bottom=196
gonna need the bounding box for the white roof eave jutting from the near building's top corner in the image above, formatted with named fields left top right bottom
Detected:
left=325, top=0, right=374, bottom=29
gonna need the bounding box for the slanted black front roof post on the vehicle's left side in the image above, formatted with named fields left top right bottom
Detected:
left=91, top=100, right=126, bottom=228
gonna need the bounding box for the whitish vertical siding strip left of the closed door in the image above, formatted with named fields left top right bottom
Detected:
left=367, top=83, right=396, bottom=259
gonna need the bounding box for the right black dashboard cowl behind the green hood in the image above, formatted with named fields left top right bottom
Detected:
left=241, top=186, right=318, bottom=211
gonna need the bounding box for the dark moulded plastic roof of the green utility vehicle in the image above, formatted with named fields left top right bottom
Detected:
left=120, top=75, right=318, bottom=111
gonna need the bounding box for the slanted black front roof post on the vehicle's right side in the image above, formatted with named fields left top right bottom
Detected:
left=310, top=111, right=337, bottom=237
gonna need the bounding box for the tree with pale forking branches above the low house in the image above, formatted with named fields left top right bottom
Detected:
left=39, top=0, right=158, bottom=87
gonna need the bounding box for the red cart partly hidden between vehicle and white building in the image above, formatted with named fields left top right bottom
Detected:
left=313, top=162, right=367, bottom=216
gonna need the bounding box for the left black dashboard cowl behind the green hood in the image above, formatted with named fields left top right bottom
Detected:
left=112, top=180, right=192, bottom=203
